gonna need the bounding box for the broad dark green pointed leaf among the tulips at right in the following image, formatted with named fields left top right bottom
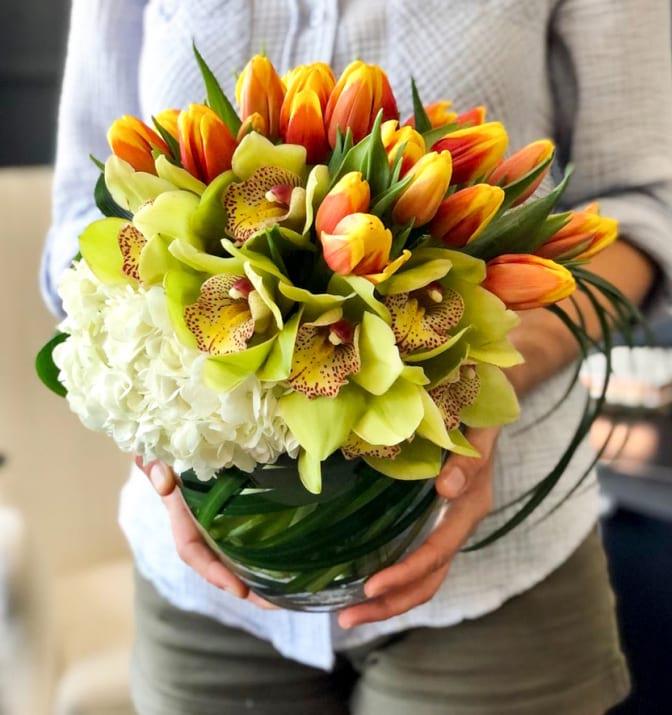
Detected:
left=462, top=167, right=571, bottom=261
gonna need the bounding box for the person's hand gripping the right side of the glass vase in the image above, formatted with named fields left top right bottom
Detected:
left=338, top=428, right=499, bottom=628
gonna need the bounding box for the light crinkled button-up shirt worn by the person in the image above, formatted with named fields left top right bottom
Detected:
left=42, top=0, right=672, bottom=668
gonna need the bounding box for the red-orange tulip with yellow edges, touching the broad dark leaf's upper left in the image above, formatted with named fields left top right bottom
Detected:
left=429, top=184, right=504, bottom=248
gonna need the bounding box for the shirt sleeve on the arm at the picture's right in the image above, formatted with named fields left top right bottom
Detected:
left=550, top=0, right=672, bottom=300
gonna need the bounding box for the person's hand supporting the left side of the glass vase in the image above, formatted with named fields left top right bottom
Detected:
left=135, top=457, right=275, bottom=608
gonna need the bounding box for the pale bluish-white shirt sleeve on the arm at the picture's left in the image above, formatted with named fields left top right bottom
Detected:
left=40, top=0, right=146, bottom=316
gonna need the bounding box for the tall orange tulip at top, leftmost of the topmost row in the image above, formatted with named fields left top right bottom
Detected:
left=236, top=55, right=285, bottom=139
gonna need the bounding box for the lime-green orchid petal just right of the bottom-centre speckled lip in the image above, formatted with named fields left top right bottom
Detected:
left=350, top=311, right=404, bottom=395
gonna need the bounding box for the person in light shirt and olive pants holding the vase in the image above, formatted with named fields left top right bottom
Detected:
left=42, top=0, right=672, bottom=715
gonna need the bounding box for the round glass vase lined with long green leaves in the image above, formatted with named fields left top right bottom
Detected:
left=180, top=454, right=444, bottom=611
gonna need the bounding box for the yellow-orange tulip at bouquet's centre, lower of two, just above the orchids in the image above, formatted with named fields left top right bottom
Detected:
left=320, top=213, right=392, bottom=276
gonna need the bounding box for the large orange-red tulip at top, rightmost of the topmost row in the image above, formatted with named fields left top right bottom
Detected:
left=325, top=60, right=399, bottom=148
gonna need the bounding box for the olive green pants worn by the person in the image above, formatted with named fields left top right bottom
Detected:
left=131, top=532, right=629, bottom=715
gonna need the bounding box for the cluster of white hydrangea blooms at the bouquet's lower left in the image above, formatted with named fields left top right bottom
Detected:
left=54, top=260, right=298, bottom=479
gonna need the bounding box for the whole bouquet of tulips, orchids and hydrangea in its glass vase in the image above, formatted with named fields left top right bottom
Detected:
left=38, top=50, right=632, bottom=608
